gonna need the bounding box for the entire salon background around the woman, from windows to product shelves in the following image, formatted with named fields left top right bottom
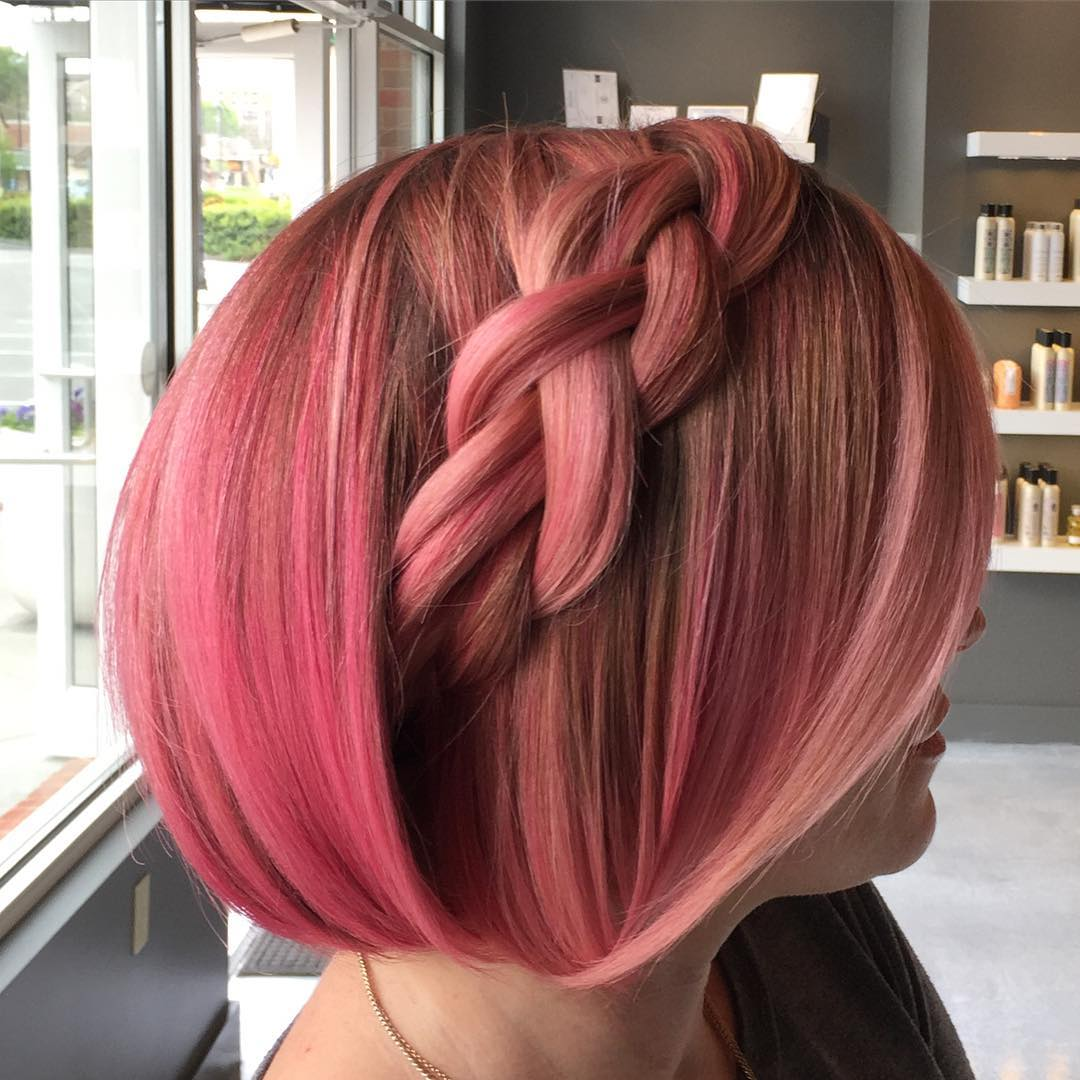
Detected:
left=0, top=0, right=1080, bottom=1080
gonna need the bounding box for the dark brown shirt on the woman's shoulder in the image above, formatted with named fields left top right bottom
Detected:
left=254, top=881, right=975, bottom=1080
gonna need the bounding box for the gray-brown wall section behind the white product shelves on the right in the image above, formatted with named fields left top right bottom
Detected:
left=922, top=0, right=1080, bottom=742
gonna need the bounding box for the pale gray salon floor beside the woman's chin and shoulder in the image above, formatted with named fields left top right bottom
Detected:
left=198, top=742, right=1080, bottom=1080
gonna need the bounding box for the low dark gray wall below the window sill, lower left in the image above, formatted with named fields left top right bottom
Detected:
left=0, top=804, right=228, bottom=1080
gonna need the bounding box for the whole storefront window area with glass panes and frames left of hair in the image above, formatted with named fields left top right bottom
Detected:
left=0, top=0, right=444, bottom=920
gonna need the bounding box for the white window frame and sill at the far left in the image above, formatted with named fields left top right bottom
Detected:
left=0, top=0, right=171, bottom=920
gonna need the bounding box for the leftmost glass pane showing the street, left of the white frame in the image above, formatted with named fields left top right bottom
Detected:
left=0, top=2, right=104, bottom=861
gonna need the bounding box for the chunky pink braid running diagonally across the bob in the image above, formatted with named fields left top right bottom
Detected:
left=393, top=121, right=801, bottom=683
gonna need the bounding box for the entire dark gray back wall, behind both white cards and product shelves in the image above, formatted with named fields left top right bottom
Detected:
left=464, top=0, right=1080, bottom=741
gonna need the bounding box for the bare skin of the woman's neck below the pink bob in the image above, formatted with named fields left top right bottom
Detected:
left=270, top=885, right=755, bottom=1080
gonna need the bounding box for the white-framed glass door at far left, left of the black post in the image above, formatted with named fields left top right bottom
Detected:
left=0, top=0, right=166, bottom=869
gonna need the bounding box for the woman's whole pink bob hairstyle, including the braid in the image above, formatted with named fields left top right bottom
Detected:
left=98, top=120, right=999, bottom=987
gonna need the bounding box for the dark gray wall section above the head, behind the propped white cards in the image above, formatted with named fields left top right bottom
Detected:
left=465, top=0, right=892, bottom=208
